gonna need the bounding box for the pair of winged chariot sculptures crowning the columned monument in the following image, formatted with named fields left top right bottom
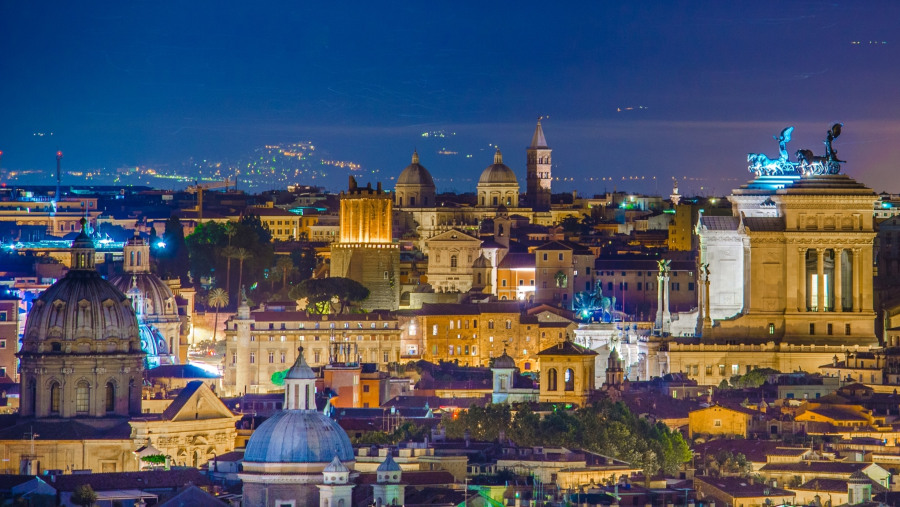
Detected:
left=747, top=123, right=844, bottom=176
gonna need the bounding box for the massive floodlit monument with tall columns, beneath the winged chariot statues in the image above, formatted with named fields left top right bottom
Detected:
left=668, top=128, right=878, bottom=384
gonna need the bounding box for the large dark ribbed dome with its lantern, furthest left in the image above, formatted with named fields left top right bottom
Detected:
left=23, top=227, right=139, bottom=354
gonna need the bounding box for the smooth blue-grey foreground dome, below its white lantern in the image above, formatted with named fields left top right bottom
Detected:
left=244, top=410, right=355, bottom=463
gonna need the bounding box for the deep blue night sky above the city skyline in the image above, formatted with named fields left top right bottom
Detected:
left=0, top=0, right=900, bottom=193
